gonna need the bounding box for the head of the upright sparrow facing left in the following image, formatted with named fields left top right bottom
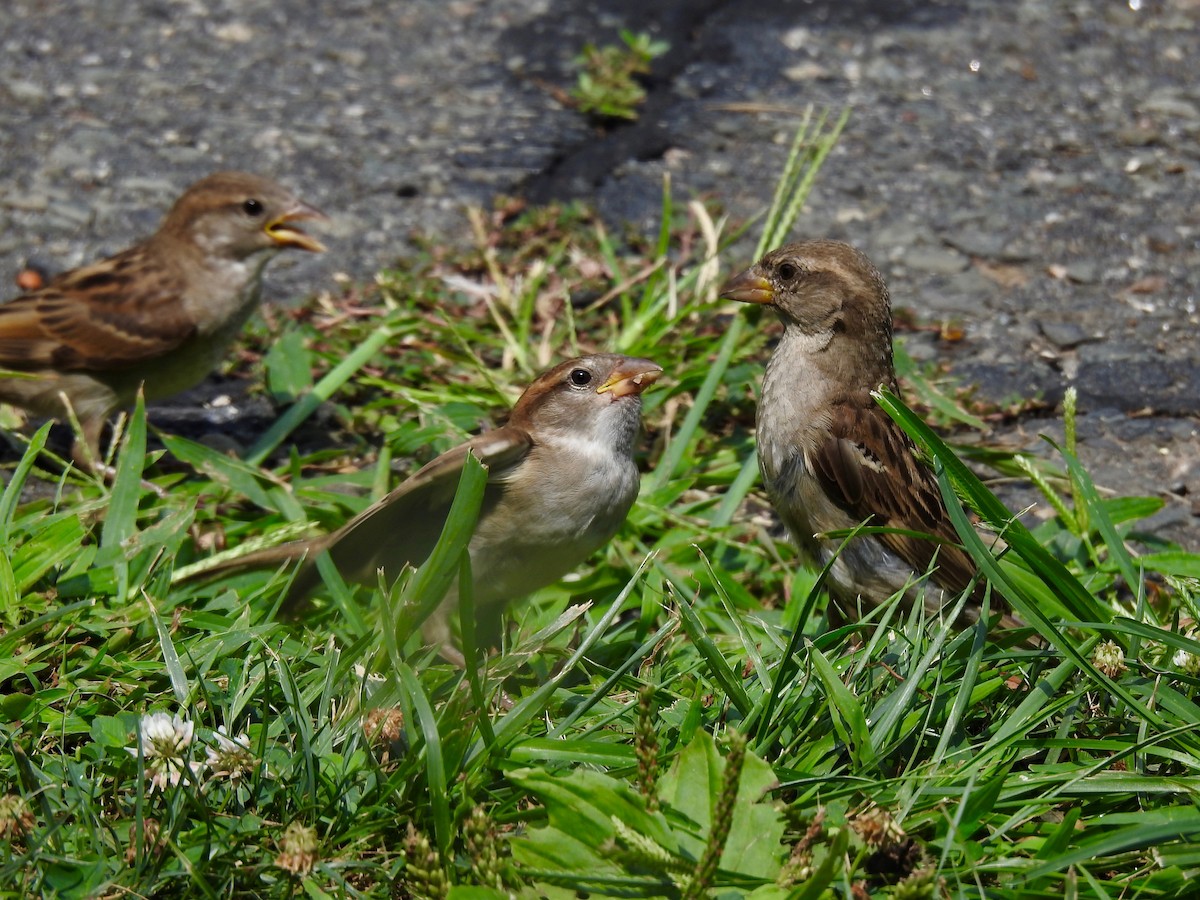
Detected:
left=721, top=240, right=892, bottom=364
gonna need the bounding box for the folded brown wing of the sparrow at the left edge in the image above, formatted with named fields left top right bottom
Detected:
left=0, top=257, right=196, bottom=371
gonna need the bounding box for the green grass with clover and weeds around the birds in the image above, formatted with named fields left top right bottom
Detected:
left=0, top=114, right=1200, bottom=899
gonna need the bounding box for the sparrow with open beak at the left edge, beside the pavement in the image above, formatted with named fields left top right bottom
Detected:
left=0, top=172, right=325, bottom=468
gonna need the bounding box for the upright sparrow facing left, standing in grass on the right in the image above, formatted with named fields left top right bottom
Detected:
left=720, top=240, right=1020, bottom=626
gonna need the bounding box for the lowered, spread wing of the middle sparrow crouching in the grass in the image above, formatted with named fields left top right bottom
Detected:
left=284, top=427, right=533, bottom=607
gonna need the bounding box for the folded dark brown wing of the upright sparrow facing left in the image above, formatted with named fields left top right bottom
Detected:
left=811, top=403, right=976, bottom=593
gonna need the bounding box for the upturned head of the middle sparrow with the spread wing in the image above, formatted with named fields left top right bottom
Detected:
left=509, top=353, right=662, bottom=455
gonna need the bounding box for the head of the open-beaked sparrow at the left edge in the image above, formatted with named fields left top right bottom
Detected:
left=158, top=172, right=326, bottom=260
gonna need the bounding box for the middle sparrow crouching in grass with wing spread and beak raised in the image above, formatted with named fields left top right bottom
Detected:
left=205, top=354, right=662, bottom=666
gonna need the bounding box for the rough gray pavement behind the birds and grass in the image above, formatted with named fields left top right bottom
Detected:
left=0, top=0, right=1200, bottom=547
